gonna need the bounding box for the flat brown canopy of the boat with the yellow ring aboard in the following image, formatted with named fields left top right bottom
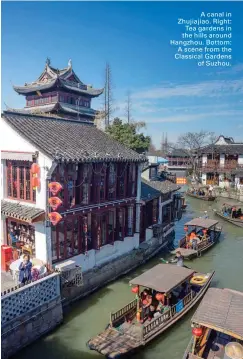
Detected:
left=130, top=264, right=194, bottom=293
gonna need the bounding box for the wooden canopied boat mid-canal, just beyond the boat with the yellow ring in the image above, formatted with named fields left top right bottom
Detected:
left=171, top=218, right=222, bottom=259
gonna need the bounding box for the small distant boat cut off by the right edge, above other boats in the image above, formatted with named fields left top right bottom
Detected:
left=215, top=202, right=243, bottom=228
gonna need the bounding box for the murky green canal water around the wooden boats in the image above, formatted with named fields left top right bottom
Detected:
left=15, top=199, right=243, bottom=359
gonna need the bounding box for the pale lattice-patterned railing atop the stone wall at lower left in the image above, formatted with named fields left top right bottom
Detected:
left=1, top=273, right=60, bottom=326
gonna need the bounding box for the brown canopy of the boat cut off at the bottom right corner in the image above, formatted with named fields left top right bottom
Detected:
left=192, top=288, right=243, bottom=340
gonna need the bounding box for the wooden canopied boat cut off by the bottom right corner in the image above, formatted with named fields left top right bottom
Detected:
left=183, top=288, right=243, bottom=359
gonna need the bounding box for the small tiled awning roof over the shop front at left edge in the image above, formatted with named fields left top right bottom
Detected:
left=1, top=200, right=45, bottom=222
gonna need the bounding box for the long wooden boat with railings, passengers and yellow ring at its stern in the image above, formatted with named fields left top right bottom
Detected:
left=87, top=264, right=214, bottom=359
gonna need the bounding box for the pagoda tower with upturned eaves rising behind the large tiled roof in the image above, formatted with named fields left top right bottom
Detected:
left=13, top=59, right=103, bottom=123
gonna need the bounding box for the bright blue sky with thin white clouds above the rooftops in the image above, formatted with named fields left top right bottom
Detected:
left=2, top=2, right=243, bottom=146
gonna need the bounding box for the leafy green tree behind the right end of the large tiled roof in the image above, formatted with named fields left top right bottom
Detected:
left=106, top=117, right=151, bottom=153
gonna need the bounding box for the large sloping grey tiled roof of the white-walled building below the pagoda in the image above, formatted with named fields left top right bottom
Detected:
left=2, top=111, right=147, bottom=162
